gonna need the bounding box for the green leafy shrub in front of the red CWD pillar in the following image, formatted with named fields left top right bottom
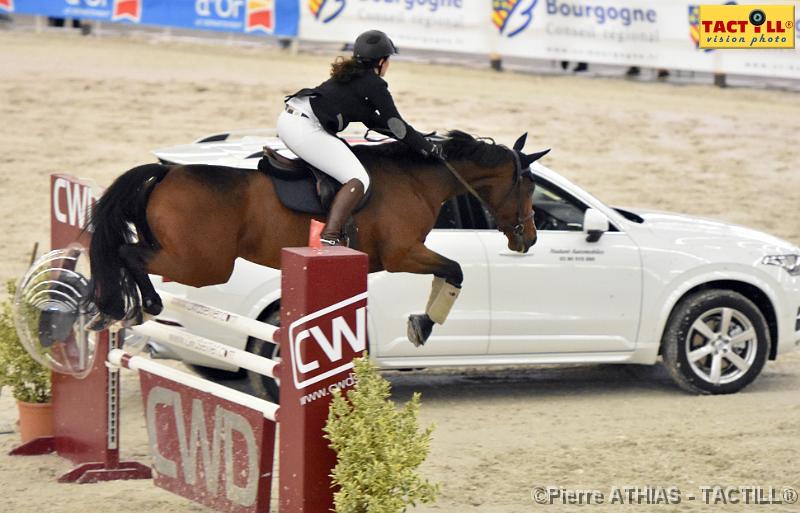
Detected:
left=325, top=357, right=438, bottom=513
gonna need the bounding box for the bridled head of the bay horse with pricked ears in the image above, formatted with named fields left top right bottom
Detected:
left=445, top=132, right=550, bottom=253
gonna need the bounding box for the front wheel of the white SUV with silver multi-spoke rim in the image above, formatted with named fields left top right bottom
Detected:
left=662, top=290, right=770, bottom=394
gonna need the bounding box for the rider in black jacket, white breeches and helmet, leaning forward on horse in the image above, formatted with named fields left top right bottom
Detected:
left=278, top=30, right=442, bottom=246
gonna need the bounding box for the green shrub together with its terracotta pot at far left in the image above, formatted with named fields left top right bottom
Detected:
left=0, top=281, right=53, bottom=443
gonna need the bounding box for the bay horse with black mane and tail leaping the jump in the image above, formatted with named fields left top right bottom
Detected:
left=89, top=131, right=549, bottom=346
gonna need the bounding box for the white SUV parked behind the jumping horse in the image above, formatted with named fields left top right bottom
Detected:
left=145, top=133, right=800, bottom=395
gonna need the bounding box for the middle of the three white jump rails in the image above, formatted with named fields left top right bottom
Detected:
left=127, top=321, right=278, bottom=378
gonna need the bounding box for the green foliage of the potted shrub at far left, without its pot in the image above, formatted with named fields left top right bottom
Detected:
left=0, top=281, right=50, bottom=403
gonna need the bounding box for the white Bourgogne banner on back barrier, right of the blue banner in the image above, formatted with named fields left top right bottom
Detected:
left=299, top=0, right=800, bottom=78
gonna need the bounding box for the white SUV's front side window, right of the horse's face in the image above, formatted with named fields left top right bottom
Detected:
left=533, top=179, right=587, bottom=232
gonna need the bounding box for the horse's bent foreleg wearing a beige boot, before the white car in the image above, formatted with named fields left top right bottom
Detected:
left=384, top=244, right=464, bottom=347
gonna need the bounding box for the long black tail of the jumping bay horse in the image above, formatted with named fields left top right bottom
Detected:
left=87, top=164, right=169, bottom=319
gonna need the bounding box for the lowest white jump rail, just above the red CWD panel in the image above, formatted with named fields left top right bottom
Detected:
left=108, top=349, right=279, bottom=422
